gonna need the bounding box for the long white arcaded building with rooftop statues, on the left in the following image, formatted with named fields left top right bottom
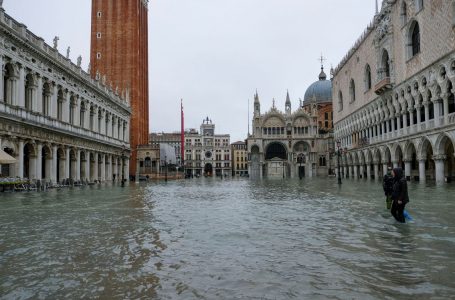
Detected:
left=0, top=7, right=131, bottom=183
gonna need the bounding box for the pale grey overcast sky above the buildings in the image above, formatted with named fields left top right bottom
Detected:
left=3, top=0, right=381, bottom=142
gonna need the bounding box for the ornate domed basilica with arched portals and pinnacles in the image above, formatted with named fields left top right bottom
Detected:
left=247, top=68, right=334, bottom=178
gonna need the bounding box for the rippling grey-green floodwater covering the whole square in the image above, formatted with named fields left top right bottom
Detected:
left=0, top=178, right=455, bottom=299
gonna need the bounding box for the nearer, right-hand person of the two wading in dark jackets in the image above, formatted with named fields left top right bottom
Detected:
left=391, top=168, right=409, bottom=223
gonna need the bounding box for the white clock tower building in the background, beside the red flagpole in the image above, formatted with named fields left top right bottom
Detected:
left=184, top=117, right=232, bottom=177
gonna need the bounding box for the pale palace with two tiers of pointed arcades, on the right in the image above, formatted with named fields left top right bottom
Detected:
left=332, top=0, right=455, bottom=182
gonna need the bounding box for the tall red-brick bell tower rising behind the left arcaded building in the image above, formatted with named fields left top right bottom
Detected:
left=90, top=0, right=149, bottom=176
